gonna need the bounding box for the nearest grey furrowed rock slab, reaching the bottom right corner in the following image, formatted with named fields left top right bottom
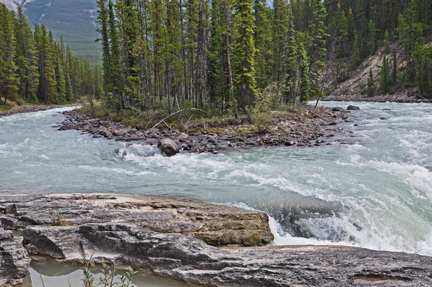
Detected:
left=23, top=223, right=432, bottom=287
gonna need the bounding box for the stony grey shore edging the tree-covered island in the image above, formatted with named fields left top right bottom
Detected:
left=59, top=107, right=355, bottom=155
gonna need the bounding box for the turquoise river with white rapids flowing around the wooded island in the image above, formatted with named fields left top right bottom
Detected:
left=0, top=102, right=432, bottom=256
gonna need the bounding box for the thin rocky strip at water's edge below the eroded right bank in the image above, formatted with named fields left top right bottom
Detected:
left=321, top=94, right=432, bottom=103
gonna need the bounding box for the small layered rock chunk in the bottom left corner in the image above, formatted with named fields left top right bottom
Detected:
left=0, top=227, right=30, bottom=287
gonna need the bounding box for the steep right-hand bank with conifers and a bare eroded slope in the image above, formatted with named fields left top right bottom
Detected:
left=325, top=0, right=432, bottom=100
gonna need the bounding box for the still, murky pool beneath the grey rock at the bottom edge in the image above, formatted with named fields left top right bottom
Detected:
left=23, top=258, right=196, bottom=287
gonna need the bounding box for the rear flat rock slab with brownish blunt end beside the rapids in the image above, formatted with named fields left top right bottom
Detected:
left=0, top=194, right=273, bottom=246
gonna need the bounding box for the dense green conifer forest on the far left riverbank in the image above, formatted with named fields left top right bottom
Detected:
left=0, top=3, right=102, bottom=107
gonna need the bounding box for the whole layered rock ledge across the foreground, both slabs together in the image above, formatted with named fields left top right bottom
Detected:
left=0, top=194, right=432, bottom=287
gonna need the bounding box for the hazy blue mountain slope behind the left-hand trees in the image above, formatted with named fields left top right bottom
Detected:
left=0, top=0, right=101, bottom=62
